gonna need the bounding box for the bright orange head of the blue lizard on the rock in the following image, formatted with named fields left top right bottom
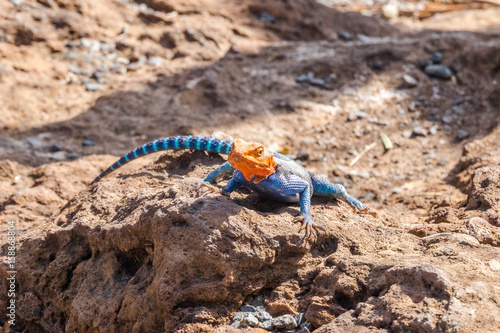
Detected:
left=227, top=139, right=276, bottom=183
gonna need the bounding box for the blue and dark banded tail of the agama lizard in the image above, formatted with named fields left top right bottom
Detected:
left=91, top=135, right=233, bottom=184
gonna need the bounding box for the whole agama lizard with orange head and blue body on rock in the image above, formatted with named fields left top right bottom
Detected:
left=92, top=136, right=377, bottom=239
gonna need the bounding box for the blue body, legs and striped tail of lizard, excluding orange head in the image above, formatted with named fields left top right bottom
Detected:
left=92, top=136, right=376, bottom=237
